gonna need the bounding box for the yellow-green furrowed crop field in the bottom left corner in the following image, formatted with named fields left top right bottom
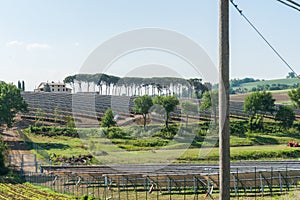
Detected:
left=0, top=183, right=74, bottom=200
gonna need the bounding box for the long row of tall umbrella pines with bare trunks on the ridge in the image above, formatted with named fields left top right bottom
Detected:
left=64, top=73, right=211, bottom=99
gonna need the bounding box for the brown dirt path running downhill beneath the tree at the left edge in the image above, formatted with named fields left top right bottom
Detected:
left=0, top=127, right=35, bottom=172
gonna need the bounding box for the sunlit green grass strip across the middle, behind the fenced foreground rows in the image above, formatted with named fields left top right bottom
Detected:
left=27, top=130, right=300, bottom=164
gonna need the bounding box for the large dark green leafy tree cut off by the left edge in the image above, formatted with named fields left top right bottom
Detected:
left=0, top=82, right=27, bottom=127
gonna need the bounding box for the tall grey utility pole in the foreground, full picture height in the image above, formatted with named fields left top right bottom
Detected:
left=219, top=0, right=230, bottom=200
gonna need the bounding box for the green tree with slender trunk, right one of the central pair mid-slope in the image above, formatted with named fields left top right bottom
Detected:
left=153, top=96, right=179, bottom=128
